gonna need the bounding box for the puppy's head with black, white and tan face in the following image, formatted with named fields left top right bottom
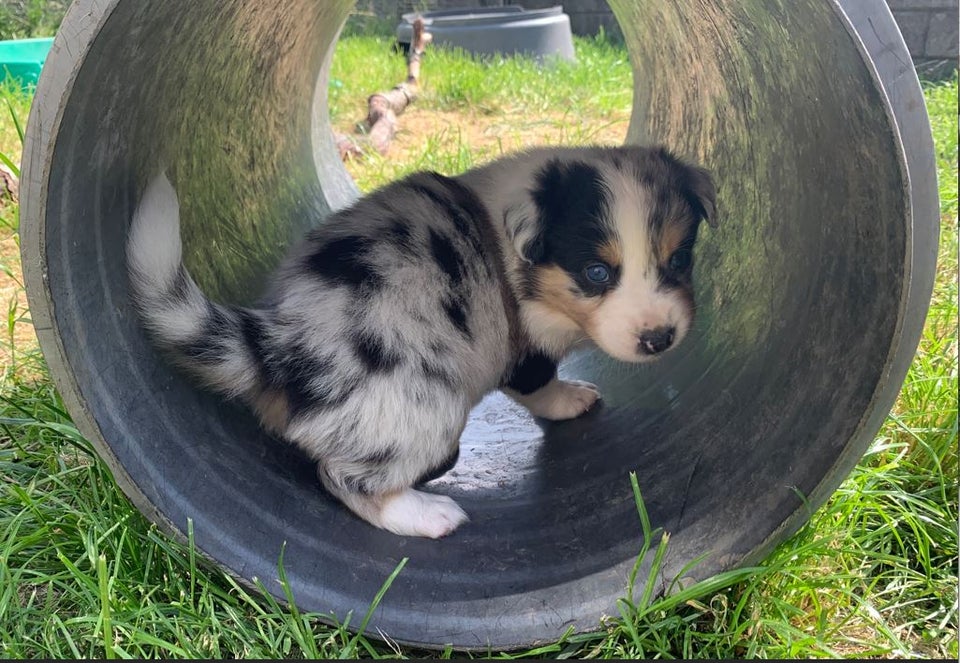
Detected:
left=506, top=147, right=716, bottom=362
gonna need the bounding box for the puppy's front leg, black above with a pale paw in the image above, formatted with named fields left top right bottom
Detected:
left=503, top=353, right=600, bottom=421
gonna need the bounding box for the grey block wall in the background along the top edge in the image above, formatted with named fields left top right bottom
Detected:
left=357, top=0, right=960, bottom=76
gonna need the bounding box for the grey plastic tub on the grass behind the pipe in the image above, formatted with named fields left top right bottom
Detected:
left=397, top=5, right=575, bottom=61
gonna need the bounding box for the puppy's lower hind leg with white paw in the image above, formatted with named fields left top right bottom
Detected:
left=317, top=452, right=468, bottom=539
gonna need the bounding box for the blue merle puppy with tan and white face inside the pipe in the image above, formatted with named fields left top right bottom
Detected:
left=127, top=146, right=716, bottom=538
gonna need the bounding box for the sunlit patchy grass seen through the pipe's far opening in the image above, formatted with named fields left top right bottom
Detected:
left=329, top=35, right=632, bottom=191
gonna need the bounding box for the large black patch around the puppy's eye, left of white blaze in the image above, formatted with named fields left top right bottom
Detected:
left=524, top=160, right=619, bottom=295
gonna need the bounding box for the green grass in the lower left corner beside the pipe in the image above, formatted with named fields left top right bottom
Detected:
left=0, top=381, right=408, bottom=659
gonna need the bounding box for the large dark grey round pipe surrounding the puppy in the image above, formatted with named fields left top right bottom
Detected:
left=21, top=0, right=938, bottom=648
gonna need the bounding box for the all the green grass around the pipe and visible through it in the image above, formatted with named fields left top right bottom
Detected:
left=0, top=27, right=958, bottom=658
